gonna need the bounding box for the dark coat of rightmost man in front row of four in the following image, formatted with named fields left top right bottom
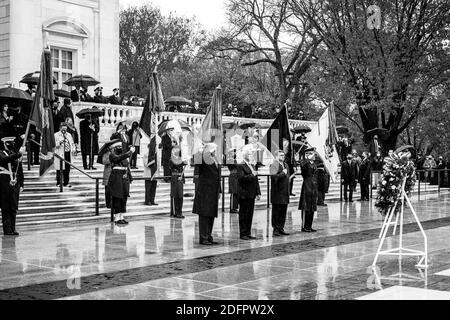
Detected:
left=298, top=161, right=317, bottom=212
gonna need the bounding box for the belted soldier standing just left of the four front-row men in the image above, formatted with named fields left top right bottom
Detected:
left=169, top=145, right=187, bottom=219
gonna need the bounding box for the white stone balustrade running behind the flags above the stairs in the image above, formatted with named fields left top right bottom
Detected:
left=72, top=102, right=317, bottom=143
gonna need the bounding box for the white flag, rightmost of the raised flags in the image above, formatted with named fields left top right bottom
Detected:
left=307, top=107, right=339, bottom=182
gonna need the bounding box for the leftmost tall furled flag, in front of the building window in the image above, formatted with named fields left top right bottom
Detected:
left=29, top=49, right=56, bottom=176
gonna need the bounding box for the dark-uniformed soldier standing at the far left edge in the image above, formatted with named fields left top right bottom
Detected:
left=0, top=137, right=25, bottom=236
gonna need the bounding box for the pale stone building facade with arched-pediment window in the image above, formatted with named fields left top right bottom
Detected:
left=0, top=0, right=119, bottom=95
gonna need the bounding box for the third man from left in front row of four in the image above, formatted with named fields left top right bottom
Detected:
left=270, top=150, right=291, bottom=237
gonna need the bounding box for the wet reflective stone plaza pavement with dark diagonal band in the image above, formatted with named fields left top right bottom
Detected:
left=0, top=193, right=450, bottom=300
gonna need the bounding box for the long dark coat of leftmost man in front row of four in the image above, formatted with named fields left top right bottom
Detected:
left=195, top=163, right=222, bottom=218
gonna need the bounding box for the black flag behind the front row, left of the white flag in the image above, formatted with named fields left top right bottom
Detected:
left=262, top=106, right=294, bottom=167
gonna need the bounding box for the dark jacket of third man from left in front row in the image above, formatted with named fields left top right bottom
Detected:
left=270, top=161, right=290, bottom=204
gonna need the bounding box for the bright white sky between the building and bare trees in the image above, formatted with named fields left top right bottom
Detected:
left=120, top=0, right=226, bottom=31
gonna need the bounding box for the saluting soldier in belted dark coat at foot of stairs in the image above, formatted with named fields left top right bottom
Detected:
left=108, top=142, right=134, bottom=225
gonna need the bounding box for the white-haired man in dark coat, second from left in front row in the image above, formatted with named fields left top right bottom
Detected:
left=238, top=145, right=261, bottom=240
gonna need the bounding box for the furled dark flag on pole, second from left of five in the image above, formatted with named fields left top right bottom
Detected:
left=140, top=71, right=165, bottom=179
